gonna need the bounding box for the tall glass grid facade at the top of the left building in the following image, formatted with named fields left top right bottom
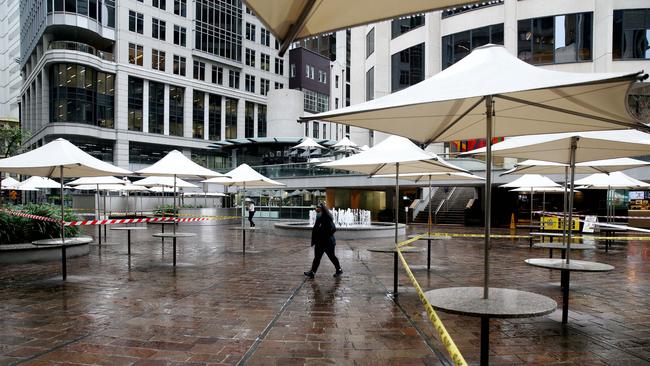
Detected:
left=194, top=0, right=242, bottom=61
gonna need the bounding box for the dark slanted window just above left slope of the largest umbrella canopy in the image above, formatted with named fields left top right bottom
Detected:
left=390, top=43, right=424, bottom=92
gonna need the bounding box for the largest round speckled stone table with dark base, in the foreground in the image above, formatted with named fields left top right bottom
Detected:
left=424, top=287, right=557, bottom=365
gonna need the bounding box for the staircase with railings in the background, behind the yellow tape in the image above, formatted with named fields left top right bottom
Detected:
left=413, top=187, right=474, bottom=225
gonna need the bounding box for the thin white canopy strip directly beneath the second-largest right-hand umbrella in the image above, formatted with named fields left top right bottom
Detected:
left=501, top=158, right=650, bottom=175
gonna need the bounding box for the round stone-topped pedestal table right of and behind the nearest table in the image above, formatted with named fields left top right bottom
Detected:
left=525, top=258, right=614, bottom=324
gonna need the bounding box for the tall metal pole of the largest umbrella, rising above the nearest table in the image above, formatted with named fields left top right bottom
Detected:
left=483, top=95, right=493, bottom=298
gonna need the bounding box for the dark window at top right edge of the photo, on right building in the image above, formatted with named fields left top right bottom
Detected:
left=612, top=9, right=650, bottom=60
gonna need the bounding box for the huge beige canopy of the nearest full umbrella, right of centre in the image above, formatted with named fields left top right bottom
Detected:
left=301, top=45, right=647, bottom=143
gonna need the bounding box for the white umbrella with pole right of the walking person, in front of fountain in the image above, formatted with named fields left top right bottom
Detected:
left=320, top=136, right=466, bottom=296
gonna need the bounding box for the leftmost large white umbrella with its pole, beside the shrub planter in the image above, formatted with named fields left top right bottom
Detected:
left=0, top=138, right=131, bottom=280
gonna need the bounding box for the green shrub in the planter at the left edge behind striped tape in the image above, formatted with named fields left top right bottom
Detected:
left=0, top=204, right=79, bottom=244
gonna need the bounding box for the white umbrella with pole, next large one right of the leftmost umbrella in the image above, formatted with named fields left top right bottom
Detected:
left=135, top=150, right=223, bottom=233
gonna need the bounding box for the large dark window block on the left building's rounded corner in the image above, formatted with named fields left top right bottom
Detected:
left=50, top=63, right=115, bottom=128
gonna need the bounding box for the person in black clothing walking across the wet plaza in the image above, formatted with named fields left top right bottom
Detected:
left=305, top=202, right=343, bottom=278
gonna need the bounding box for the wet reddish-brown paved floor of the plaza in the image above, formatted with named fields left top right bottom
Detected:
left=0, top=222, right=650, bottom=365
